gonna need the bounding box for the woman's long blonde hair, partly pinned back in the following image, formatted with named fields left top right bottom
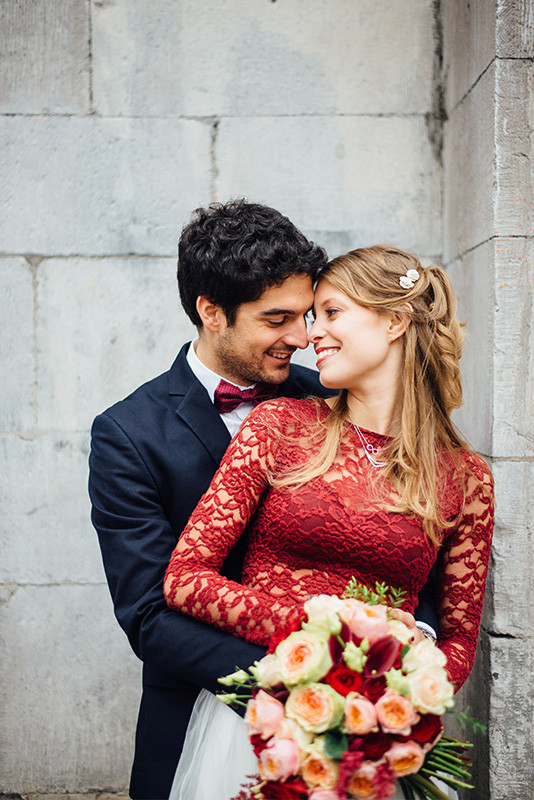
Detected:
left=272, top=245, right=467, bottom=543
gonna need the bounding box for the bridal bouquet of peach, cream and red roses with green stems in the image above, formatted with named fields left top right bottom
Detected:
left=219, top=583, right=480, bottom=800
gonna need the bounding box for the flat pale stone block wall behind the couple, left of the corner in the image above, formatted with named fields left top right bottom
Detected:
left=0, top=0, right=441, bottom=795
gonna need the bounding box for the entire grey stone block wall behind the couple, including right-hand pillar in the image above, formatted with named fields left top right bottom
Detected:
left=0, top=0, right=532, bottom=800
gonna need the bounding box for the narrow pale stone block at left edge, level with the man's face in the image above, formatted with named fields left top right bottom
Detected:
left=0, top=258, right=35, bottom=431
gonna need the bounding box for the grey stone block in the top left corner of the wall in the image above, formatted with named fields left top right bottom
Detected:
left=0, top=0, right=90, bottom=114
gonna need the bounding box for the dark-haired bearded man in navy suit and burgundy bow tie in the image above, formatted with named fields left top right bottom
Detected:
left=89, top=201, right=438, bottom=800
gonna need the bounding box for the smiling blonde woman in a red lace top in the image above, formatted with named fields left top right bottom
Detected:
left=164, top=245, right=493, bottom=800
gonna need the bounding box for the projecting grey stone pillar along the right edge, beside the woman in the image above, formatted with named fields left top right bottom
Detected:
left=441, top=0, right=534, bottom=800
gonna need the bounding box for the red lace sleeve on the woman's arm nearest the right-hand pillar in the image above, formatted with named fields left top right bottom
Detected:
left=438, top=456, right=494, bottom=691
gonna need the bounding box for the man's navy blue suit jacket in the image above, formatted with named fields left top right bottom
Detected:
left=89, top=345, right=435, bottom=800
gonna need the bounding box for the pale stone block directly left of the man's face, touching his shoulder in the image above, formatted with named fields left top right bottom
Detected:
left=37, top=258, right=195, bottom=431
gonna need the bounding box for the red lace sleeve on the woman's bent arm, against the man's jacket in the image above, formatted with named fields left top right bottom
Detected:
left=163, top=401, right=298, bottom=644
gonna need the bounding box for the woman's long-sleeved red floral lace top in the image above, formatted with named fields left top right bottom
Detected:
left=165, top=398, right=493, bottom=688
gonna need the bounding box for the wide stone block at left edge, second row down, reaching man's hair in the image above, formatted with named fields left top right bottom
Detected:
left=0, top=116, right=211, bottom=256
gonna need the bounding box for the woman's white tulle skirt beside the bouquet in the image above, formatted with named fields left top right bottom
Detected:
left=169, top=689, right=458, bottom=800
